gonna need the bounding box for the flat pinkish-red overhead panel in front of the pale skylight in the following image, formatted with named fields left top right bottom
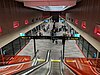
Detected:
left=24, top=1, right=76, bottom=6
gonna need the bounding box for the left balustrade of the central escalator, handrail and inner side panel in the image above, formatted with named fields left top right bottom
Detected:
left=14, top=50, right=51, bottom=75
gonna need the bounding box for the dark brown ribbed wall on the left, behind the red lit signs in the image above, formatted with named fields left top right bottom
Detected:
left=0, top=0, right=42, bottom=36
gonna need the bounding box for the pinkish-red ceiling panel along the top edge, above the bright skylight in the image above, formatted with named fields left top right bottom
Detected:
left=16, top=0, right=77, bottom=6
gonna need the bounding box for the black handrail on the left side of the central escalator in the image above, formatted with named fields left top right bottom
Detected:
left=13, top=50, right=51, bottom=75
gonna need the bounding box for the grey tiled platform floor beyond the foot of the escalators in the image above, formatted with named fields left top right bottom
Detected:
left=18, top=23, right=84, bottom=59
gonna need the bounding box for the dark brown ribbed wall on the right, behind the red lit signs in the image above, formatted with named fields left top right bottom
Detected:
left=66, top=0, right=100, bottom=42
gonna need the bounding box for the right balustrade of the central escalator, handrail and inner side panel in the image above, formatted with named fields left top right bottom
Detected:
left=60, top=51, right=77, bottom=75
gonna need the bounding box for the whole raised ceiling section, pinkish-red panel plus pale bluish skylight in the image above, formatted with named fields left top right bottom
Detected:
left=16, top=0, right=77, bottom=11
